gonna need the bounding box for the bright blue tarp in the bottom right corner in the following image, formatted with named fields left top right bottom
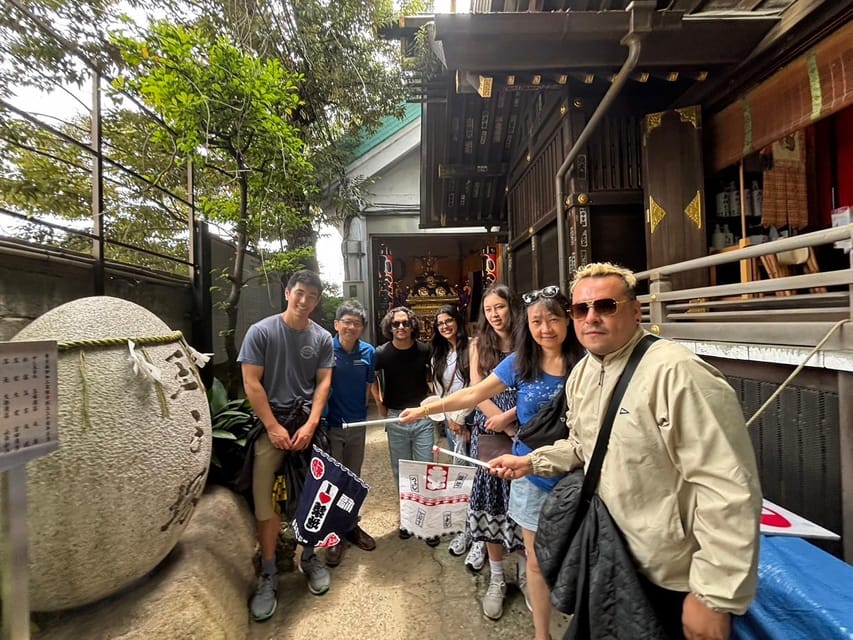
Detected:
left=733, top=536, right=853, bottom=640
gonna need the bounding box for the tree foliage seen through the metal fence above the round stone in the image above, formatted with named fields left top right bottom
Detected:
left=0, top=110, right=188, bottom=274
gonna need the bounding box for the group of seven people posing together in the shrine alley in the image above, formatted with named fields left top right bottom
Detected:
left=239, top=263, right=761, bottom=640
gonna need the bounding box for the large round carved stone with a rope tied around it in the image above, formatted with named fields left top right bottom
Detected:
left=0, top=297, right=211, bottom=611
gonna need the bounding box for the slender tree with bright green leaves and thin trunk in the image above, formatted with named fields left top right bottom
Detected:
left=113, top=22, right=313, bottom=392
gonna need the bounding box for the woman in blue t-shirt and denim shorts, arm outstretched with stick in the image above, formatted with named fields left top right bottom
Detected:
left=400, top=286, right=580, bottom=640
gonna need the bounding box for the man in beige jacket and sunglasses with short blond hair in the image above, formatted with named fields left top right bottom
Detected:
left=490, top=263, right=761, bottom=640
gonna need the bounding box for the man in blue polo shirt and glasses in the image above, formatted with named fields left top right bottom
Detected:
left=325, top=300, right=381, bottom=567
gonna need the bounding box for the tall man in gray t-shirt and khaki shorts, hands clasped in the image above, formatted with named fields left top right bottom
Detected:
left=237, top=270, right=335, bottom=622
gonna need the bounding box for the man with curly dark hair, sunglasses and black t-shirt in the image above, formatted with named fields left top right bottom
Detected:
left=376, top=307, right=440, bottom=547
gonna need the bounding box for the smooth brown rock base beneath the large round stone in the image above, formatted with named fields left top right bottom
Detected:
left=33, top=487, right=256, bottom=640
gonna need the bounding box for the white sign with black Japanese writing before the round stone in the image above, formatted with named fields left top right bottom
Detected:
left=0, top=341, right=59, bottom=470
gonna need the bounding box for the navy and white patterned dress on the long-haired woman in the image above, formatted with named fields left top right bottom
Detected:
left=468, top=390, right=524, bottom=552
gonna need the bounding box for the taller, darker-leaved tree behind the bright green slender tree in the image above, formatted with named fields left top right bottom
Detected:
left=157, top=0, right=404, bottom=269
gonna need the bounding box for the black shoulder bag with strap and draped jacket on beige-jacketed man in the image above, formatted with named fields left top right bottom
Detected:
left=535, top=335, right=666, bottom=640
